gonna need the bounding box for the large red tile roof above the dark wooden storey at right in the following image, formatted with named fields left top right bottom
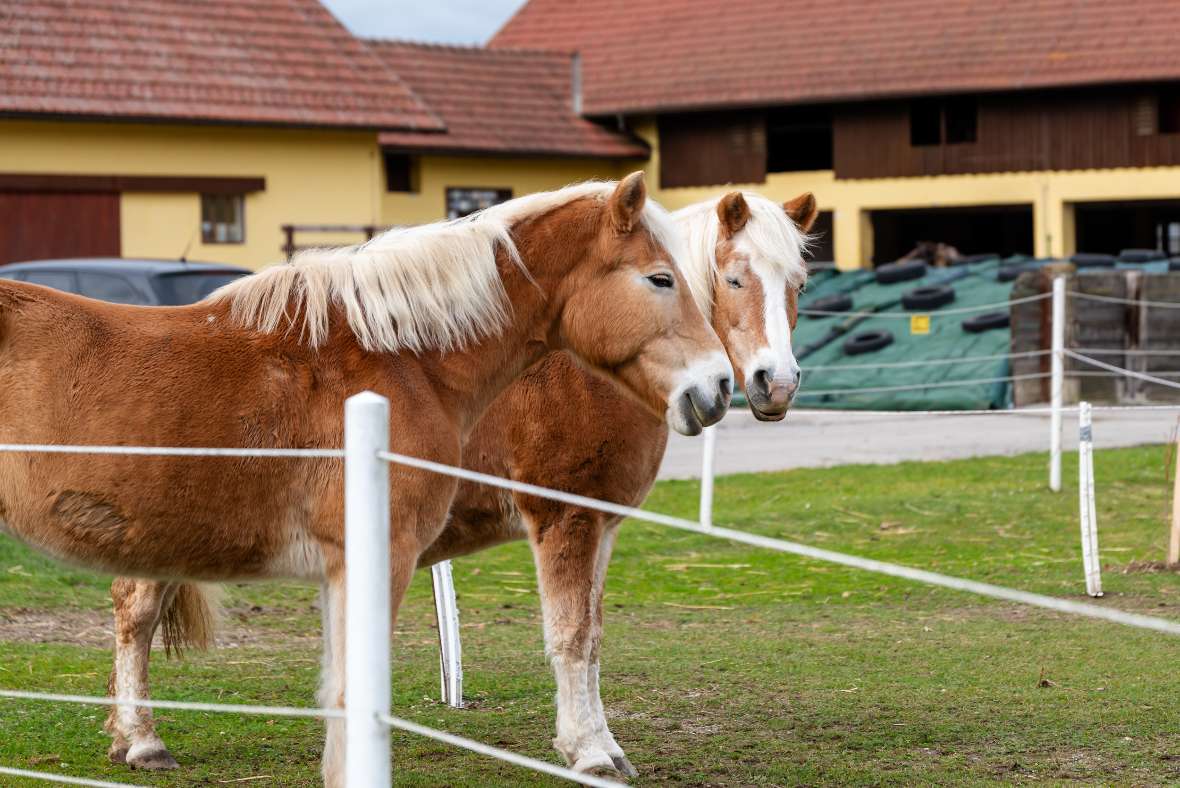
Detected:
left=490, top=0, right=1180, bottom=114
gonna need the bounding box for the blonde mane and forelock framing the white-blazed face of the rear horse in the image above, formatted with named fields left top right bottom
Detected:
left=671, top=191, right=811, bottom=315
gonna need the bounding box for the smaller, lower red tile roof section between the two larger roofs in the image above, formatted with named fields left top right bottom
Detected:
left=369, top=41, right=648, bottom=158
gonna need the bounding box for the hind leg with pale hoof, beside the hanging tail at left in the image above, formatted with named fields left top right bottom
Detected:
left=104, top=578, right=178, bottom=769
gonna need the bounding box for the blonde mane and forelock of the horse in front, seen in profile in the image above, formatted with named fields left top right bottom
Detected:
left=209, top=180, right=677, bottom=353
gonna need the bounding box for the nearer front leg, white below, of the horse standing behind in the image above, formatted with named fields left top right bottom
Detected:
left=525, top=504, right=616, bottom=774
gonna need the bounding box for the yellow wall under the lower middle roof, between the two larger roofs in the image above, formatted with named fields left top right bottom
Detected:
left=381, top=156, right=641, bottom=225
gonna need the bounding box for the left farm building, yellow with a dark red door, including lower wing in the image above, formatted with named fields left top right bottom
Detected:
left=0, top=0, right=648, bottom=268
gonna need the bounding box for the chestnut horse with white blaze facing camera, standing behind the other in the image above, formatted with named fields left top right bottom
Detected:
left=107, top=187, right=817, bottom=775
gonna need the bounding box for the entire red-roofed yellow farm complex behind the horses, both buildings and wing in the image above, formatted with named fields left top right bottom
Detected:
left=0, top=0, right=1180, bottom=268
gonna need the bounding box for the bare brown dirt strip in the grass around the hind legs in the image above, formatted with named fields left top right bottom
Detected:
left=0, top=608, right=320, bottom=649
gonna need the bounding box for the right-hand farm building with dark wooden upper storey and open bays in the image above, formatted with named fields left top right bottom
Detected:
left=490, top=0, right=1180, bottom=268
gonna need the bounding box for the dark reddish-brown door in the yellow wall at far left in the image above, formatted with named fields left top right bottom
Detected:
left=0, top=191, right=119, bottom=264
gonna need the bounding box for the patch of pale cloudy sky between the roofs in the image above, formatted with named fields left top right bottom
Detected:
left=322, top=0, right=524, bottom=44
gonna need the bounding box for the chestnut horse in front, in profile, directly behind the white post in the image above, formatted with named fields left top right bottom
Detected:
left=0, top=173, right=732, bottom=786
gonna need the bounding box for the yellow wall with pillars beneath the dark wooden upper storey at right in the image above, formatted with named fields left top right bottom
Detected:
left=635, top=114, right=1180, bottom=268
